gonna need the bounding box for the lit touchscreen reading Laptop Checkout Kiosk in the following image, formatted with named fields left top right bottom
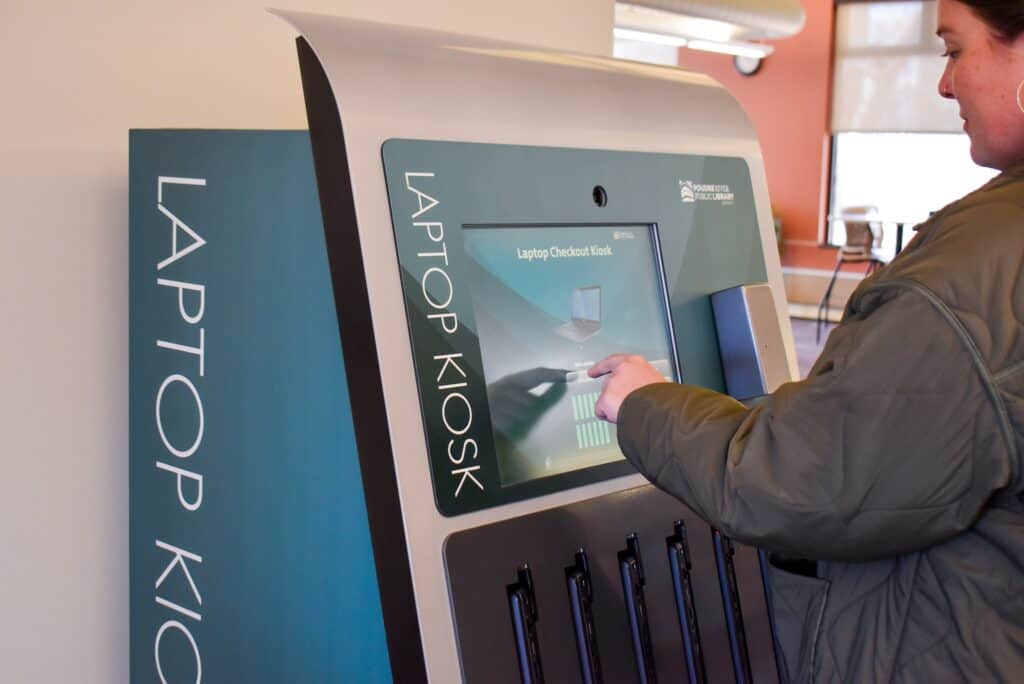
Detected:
left=463, top=225, right=678, bottom=486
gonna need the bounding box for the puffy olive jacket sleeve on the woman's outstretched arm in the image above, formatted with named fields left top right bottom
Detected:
left=618, top=282, right=1011, bottom=561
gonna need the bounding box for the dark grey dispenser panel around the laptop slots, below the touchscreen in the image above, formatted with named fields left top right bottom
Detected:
left=444, top=485, right=777, bottom=684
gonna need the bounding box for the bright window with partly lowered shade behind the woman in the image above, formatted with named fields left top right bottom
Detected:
left=826, top=0, right=995, bottom=254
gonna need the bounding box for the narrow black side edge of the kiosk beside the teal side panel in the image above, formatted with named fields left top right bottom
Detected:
left=296, top=37, right=427, bottom=684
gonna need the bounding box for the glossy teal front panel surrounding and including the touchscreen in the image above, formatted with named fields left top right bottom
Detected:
left=383, top=139, right=767, bottom=516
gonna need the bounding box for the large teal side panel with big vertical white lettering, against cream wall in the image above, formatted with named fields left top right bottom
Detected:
left=129, top=130, right=391, bottom=683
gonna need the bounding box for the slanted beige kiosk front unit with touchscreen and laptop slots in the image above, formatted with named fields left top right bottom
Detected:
left=283, top=13, right=792, bottom=682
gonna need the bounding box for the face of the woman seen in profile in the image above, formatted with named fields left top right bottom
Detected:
left=937, top=0, right=1024, bottom=169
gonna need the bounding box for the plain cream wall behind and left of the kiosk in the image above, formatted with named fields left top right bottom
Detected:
left=0, top=0, right=613, bottom=684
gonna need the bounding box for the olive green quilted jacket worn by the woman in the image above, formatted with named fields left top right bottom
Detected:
left=618, top=167, right=1024, bottom=684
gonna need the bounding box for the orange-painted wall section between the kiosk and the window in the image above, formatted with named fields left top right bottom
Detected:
left=679, top=0, right=836, bottom=269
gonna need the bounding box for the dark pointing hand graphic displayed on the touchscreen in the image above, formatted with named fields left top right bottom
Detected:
left=487, top=367, right=568, bottom=439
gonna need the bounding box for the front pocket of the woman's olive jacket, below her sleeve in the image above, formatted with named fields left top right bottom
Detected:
left=767, top=561, right=830, bottom=684
